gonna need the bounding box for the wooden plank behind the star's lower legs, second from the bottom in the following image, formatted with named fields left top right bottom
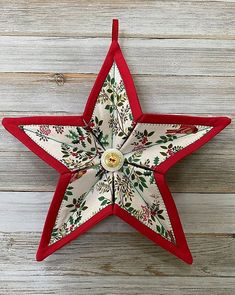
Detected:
left=0, top=192, right=235, bottom=234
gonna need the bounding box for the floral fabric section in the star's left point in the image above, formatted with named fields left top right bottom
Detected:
left=21, top=125, right=103, bottom=171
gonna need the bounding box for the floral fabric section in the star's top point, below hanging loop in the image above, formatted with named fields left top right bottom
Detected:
left=89, top=63, right=133, bottom=148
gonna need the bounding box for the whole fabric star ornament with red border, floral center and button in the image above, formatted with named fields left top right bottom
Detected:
left=3, top=20, right=231, bottom=264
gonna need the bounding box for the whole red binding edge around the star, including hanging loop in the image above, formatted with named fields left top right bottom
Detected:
left=2, top=19, right=231, bottom=264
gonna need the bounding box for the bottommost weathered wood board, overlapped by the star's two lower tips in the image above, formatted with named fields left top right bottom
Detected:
left=0, top=233, right=235, bottom=294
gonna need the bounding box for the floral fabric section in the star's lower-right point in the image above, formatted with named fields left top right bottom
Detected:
left=114, top=164, right=175, bottom=243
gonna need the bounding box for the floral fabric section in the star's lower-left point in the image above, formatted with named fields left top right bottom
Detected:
left=50, top=167, right=112, bottom=245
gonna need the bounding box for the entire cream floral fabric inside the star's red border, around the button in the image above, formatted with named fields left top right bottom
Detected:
left=21, top=63, right=212, bottom=244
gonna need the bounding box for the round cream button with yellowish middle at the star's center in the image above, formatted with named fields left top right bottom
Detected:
left=101, top=149, right=124, bottom=172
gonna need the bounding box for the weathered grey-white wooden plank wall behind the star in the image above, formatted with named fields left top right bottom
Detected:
left=0, top=0, right=235, bottom=295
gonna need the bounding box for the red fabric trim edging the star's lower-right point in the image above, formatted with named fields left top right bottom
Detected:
left=114, top=173, right=193, bottom=264
